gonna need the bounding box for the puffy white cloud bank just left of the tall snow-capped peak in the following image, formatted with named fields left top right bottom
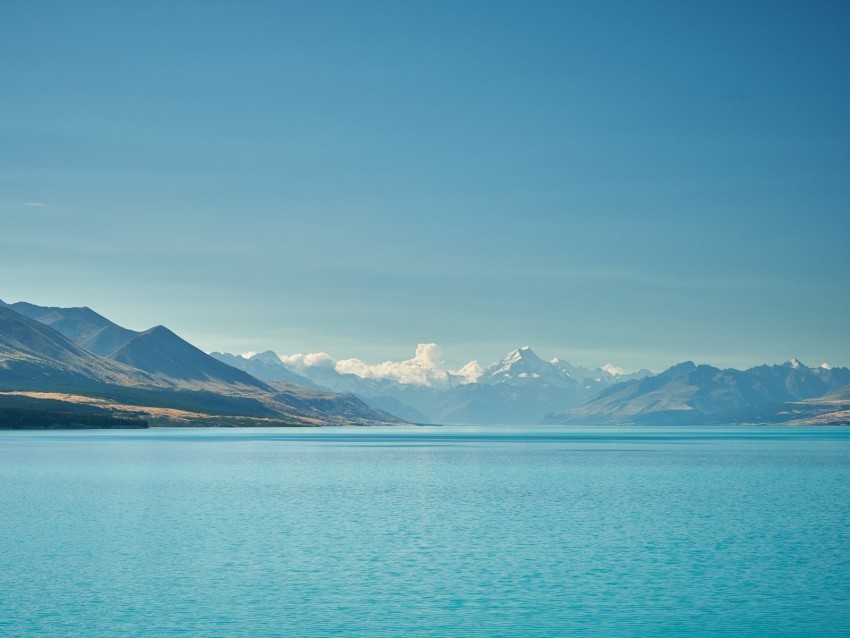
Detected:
left=280, top=343, right=482, bottom=388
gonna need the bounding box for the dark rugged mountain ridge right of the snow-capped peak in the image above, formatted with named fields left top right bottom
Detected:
left=546, top=361, right=850, bottom=424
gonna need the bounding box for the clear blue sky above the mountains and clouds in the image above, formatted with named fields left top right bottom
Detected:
left=0, top=0, right=850, bottom=371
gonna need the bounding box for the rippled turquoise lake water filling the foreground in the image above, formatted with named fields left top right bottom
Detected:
left=0, top=427, right=850, bottom=636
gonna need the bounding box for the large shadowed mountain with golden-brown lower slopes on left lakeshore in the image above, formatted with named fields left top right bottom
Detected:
left=0, top=304, right=400, bottom=425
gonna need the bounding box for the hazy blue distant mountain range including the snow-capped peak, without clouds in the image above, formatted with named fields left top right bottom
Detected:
left=212, top=345, right=850, bottom=424
